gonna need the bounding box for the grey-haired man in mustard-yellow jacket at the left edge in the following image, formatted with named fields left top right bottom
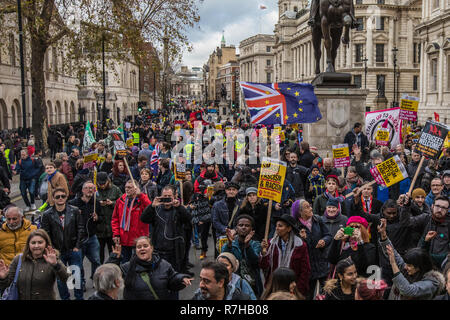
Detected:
left=0, top=205, right=37, bottom=265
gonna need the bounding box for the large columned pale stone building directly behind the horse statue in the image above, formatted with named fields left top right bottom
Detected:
left=274, top=0, right=422, bottom=110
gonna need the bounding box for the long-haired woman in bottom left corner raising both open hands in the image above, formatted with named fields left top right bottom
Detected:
left=0, top=229, right=69, bottom=300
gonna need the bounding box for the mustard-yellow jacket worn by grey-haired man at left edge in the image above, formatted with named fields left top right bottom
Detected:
left=0, top=218, right=37, bottom=265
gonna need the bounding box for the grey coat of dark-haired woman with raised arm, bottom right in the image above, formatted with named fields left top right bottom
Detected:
left=379, top=239, right=445, bottom=300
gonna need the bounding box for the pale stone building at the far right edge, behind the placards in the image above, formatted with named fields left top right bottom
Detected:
left=416, top=0, right=450, bottom=124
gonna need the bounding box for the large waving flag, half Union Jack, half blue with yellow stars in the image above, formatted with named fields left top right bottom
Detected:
left=240, top=82, right=322, bottom=125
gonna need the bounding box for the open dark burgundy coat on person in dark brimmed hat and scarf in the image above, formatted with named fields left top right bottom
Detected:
left=259, top=236, right=311, bottom=296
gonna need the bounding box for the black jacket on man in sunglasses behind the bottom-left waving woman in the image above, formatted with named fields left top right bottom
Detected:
left=41, top=204, right=85, bottom=252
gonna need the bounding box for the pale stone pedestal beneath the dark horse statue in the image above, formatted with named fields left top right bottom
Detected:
left=303, top=87, right=369, bottom=157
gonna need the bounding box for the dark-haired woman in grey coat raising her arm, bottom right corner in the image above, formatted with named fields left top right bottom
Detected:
left=378, top=222, right=445, bottom=300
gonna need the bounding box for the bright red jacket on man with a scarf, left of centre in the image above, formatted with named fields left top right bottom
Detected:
left=111, top=193, right=152, bottom=247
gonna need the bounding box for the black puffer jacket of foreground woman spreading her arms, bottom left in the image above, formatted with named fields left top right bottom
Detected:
left=106, top=253, right=189, bottom=300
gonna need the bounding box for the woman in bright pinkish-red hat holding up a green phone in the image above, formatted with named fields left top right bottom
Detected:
left=328, top=216, right=376, bottom=277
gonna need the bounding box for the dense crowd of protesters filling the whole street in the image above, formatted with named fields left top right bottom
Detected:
left=0, top=113, right=450, bottom=300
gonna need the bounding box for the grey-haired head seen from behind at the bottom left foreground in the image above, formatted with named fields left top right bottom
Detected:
left=89, top=263, right=123, bottom=300
